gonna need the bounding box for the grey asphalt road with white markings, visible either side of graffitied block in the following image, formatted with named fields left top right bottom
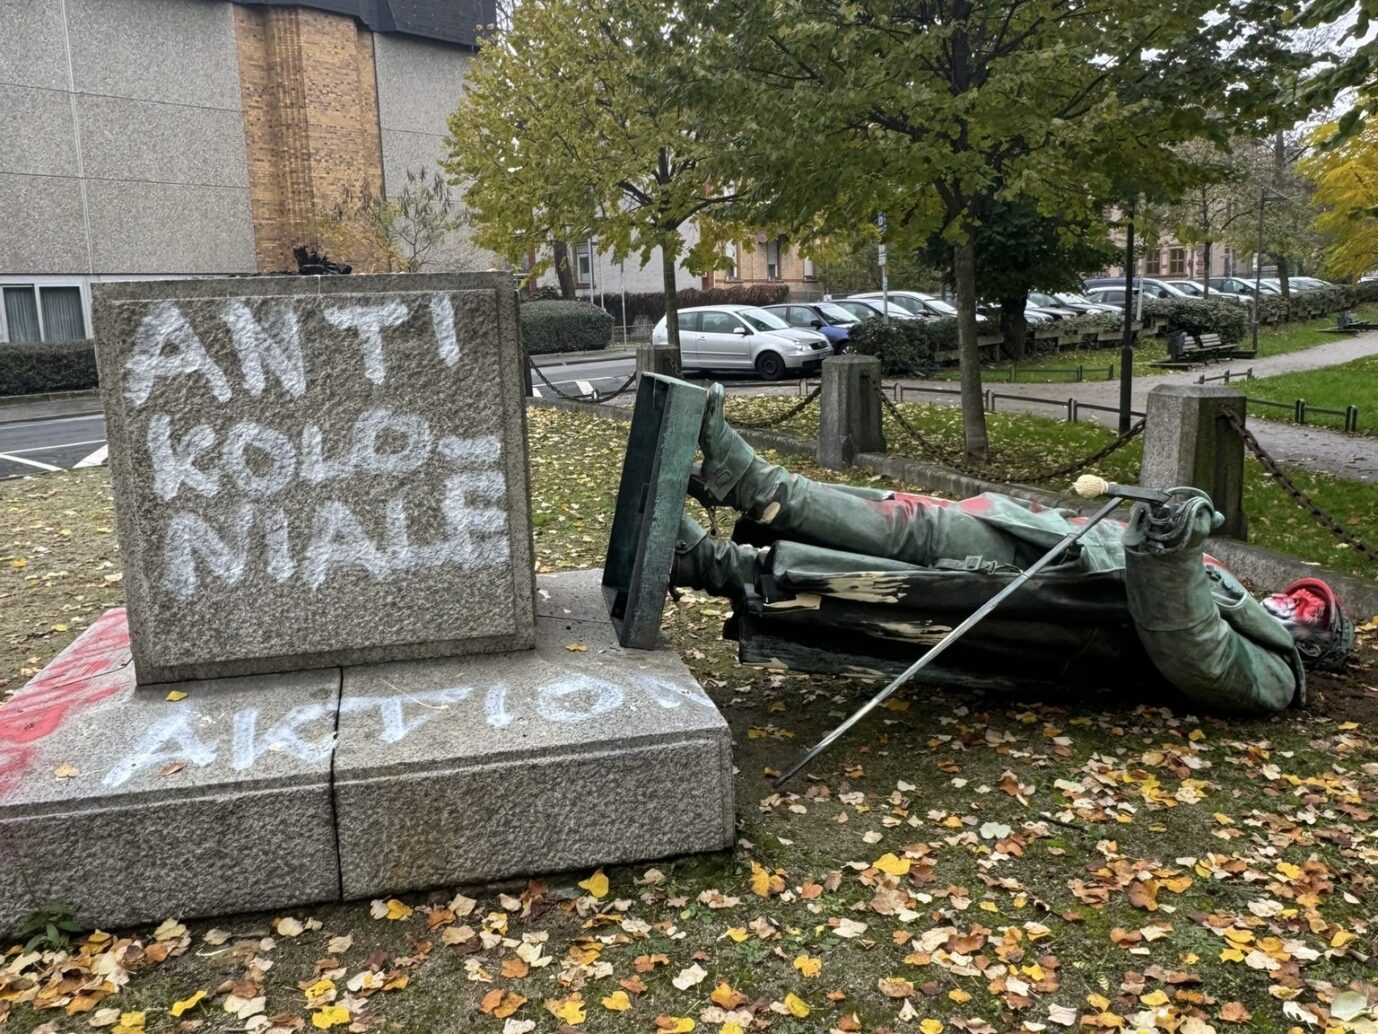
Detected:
left=0, top=354, right=637, bottom=478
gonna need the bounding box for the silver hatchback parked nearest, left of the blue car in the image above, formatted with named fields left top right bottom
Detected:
left=650, top=305, right=832, bottom=381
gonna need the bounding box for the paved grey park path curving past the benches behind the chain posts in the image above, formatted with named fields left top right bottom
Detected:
left=901, top=331, right=1378, bottom=483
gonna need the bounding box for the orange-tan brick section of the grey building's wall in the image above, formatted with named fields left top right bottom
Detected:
left=234, top=6, right=383, bottom=272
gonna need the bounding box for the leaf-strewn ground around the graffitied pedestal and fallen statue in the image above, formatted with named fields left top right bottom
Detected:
left=0, top=409, right=1378, bottom=1034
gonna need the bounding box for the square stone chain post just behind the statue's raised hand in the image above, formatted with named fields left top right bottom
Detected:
left=1138, top=385, right=1248, bottom=540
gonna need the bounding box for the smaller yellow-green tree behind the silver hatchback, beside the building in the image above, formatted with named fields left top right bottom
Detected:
left=442, top=0, right=736, bottom=347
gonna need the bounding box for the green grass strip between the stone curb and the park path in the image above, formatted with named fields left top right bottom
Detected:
left=729, top=394, right=1378, bottom=578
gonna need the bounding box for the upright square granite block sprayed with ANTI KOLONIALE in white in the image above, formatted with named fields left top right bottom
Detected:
left=94, top=273, right=535, bottom=684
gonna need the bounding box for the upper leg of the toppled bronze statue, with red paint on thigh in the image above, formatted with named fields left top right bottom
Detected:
left=699, top=385, right=1024, bottom=565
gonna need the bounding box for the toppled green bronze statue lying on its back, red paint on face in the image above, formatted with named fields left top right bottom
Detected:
left=671, top=385, right=1353, bottom=714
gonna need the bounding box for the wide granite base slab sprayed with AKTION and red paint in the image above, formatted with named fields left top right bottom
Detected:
left=0, top=571, right=734, bottom=929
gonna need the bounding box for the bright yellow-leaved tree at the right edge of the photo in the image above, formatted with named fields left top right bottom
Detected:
left=1301, top=123, right=1378, bottom=277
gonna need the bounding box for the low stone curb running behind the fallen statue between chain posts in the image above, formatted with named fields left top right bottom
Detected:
left=526, top=398, right=1378, bottom=620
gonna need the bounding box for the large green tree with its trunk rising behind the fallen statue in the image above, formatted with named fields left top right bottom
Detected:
left=712, top=0, right=1311, bottom=459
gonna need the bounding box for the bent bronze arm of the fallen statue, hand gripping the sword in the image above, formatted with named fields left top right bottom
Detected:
left=1124, top=499, right=1305, bottom=714
